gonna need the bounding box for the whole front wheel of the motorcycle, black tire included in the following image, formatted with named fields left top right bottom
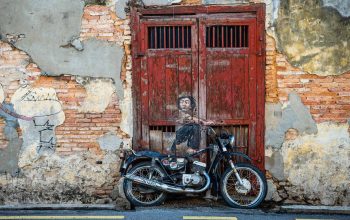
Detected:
left=220, top=164, right=267, bottom=209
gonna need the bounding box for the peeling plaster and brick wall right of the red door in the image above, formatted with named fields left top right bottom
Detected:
left=265, top=0, right=350, bottom=206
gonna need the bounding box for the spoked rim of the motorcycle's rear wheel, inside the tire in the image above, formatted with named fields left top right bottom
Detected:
left=127, top=166, right=164, bottom=205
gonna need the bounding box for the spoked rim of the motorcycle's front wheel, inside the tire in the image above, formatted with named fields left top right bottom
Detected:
left=223, top=167, right=264, bottom=206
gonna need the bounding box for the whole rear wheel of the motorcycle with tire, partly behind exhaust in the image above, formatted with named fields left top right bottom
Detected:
left=123, top=161, right=166, bottom=206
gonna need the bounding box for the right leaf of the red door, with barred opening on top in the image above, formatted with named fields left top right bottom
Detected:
left=199, top=18, right=257, bottom=159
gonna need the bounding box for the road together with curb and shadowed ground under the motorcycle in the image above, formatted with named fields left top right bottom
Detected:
left=0, top=197, right=350, bottom=220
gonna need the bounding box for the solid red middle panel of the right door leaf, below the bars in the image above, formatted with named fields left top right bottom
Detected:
left=206, top=54, right=249, bottom=120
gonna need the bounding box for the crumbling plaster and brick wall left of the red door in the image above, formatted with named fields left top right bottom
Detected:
left=0, top=0, right=132, bottom=204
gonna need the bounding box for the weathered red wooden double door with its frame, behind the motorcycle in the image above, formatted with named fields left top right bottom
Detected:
left=133, top=6, right=264, bottom=168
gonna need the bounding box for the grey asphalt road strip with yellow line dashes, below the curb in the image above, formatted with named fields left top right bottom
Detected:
left=0, top=207, right=350, bottom=220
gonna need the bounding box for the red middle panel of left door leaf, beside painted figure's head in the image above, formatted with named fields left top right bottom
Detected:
left=147, top=54, right=192, bottom=122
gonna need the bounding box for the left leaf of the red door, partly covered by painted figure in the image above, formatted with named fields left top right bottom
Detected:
left=141, top=19, right=198, bottom=151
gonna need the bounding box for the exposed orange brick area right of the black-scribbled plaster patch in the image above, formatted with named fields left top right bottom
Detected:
left=29, top=76, right=121, bottom=155
